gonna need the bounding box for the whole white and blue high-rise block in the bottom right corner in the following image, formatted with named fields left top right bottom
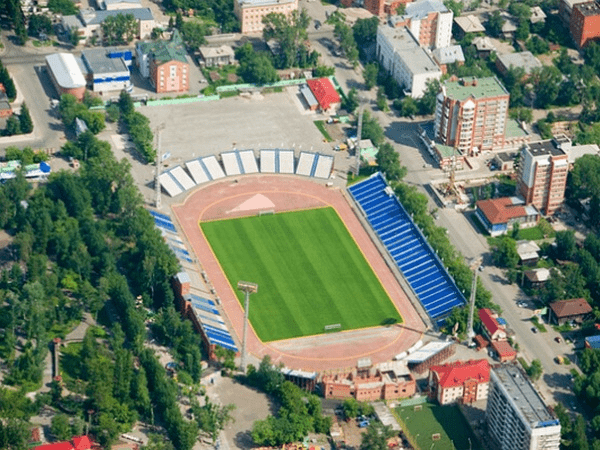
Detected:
left=486, top=364, right=560, bottom=450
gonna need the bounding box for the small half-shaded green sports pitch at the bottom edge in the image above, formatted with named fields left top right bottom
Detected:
left=396, top=403, right=482, bottom=450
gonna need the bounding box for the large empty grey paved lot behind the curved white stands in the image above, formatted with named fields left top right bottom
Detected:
left=119, top=88, right=351, bottom=202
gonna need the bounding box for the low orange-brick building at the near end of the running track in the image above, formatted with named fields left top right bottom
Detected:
left=321, top=360, right=417, bottom=402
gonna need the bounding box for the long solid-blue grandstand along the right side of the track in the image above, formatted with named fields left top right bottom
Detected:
left=349, top=173, right=466, bottom=324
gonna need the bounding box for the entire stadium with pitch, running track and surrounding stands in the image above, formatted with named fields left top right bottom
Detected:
left=151, top=149, right=464, bottom=372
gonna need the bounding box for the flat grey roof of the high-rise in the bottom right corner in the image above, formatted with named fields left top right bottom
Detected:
left=492, top=364, right=558, bottom=428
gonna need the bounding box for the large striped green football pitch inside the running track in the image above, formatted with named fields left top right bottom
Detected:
left=200, top=208, right=402, bottom=342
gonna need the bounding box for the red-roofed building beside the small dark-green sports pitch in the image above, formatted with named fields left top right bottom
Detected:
left=429, top=359, right=490, bottom=405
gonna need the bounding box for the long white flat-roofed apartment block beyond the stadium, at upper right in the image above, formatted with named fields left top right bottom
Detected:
left=377, top=25, right=442, bottom=98
